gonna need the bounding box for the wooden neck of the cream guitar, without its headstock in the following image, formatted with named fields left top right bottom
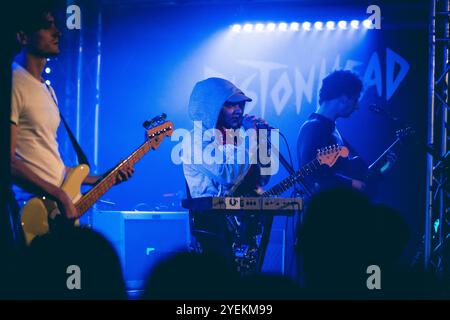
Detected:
left=75, top=141, right=151, bottom=218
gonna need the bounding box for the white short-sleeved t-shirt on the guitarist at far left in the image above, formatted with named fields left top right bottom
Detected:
left=11, top=62, right=64, bottom=192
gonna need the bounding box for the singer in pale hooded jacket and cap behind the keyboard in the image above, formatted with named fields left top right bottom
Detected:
left=183, top=78, right=269, bottom=270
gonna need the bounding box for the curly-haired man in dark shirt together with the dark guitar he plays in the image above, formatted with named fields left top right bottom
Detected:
left=297, top=70, right=400, bottom=196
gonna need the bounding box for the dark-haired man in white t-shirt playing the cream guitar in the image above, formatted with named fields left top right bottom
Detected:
left=10, top=1, right=133, bottom=230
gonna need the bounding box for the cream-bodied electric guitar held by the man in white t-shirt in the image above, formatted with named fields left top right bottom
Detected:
left=21, top=115, right=174, bottom=245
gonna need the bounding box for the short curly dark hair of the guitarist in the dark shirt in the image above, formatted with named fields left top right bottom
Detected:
left=319, top=70, right=363, bottom=105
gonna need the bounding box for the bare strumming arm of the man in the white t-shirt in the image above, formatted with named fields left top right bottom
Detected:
left=10, top=123, right=77, bottom=218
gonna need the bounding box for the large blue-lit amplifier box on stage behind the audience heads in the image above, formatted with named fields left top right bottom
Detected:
left=92, top=211, right=190, bottom=290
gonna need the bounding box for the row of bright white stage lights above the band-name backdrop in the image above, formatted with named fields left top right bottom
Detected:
left=231, top=20, right=373, bottom=32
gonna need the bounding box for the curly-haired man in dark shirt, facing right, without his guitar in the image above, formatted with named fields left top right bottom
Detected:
left=297, top=70, right=366, bottom=194
